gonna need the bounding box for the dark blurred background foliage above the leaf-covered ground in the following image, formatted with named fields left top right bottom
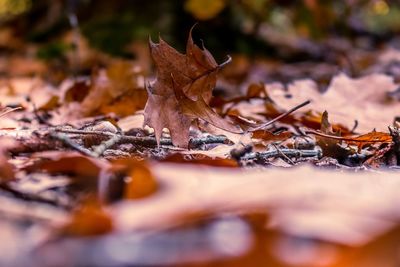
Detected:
left=0, top=0, right=400, bottom=67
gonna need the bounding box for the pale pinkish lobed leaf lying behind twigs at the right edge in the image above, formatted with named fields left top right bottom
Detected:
left=267, top=74, right=400, bottom=133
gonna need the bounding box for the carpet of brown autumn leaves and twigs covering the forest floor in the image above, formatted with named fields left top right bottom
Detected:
left=0, top=25, right=400, bottom=266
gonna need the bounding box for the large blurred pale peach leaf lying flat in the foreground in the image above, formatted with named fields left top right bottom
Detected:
left=110, top=163, right=400, bottom=250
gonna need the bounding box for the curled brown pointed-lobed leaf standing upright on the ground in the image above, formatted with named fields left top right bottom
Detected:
left=144, top=28, right=242, bottom=148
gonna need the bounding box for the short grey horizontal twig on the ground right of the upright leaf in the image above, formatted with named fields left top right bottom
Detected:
left=242, top=148, right=322, bottom=160
